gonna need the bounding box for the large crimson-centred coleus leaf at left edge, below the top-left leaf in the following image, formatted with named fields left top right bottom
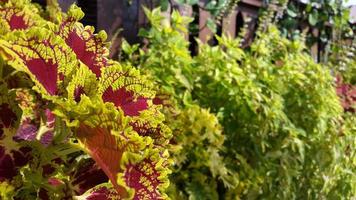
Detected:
left=0, top=28, right=79, bottom=95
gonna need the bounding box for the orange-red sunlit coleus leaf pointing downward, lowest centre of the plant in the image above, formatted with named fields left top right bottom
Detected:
left=77, top=124, right=150, bottom=197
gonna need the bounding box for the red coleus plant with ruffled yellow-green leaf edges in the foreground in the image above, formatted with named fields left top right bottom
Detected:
left=0, top=0, right=171, bottom=199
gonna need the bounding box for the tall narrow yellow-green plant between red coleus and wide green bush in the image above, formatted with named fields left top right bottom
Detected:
left=128, top=9, right=236, bottom=199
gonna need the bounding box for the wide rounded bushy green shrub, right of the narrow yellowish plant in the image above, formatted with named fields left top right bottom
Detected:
left=193, top=27, right=352, bottom=199
